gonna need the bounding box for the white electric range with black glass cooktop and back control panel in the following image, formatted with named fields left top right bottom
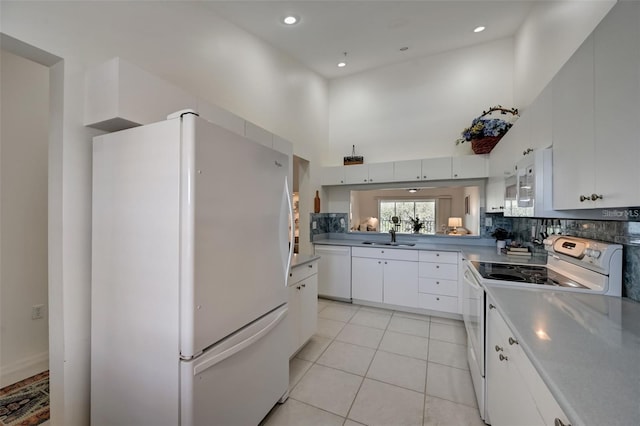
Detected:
left=462, top=235, right=622, bottom=423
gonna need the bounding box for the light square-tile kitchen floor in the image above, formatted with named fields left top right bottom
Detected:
left=262, top=299, right=484, bottom=426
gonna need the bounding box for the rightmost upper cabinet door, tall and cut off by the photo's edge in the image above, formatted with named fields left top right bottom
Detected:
left=583, top=2, right=640, bottom=207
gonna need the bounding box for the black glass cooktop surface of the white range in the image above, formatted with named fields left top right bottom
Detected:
left=471, top=262, right=586, bottom=288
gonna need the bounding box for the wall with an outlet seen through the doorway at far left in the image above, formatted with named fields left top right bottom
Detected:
left=0, top=50, right=49, bottom=387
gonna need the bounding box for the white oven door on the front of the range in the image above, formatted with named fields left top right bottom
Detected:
left=462, top=262, right=484, bottom=377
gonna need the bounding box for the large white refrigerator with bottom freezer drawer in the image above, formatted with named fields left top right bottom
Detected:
left=91, top=113, right=293, bottom=426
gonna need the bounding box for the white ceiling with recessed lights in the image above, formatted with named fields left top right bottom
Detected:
left=202, top=0, right=535, bottom=79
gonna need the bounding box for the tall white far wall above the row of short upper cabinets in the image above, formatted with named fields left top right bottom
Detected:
left=330, top=39, right=513, bottom=166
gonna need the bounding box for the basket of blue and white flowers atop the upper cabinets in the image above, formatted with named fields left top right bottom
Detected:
left=456, top=105, right=519, bottom=154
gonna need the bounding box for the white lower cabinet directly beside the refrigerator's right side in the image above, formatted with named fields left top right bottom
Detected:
left=288, top=261, right=318, bottom=357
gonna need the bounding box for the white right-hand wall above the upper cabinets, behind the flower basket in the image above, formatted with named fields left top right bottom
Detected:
left=514, top=0, right=616, bottom=110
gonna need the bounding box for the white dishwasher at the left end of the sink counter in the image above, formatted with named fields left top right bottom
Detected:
left=314, top=244, right=351, bottom=301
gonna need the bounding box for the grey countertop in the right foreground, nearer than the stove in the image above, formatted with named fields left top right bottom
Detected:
left=485, top=284, right=640, bottom=426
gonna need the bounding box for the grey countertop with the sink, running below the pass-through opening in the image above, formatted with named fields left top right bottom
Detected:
left=313, top=238, right=547, bottom=265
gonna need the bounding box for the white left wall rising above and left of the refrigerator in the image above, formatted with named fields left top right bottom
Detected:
left=0, top=1, right=328, bottom=426
